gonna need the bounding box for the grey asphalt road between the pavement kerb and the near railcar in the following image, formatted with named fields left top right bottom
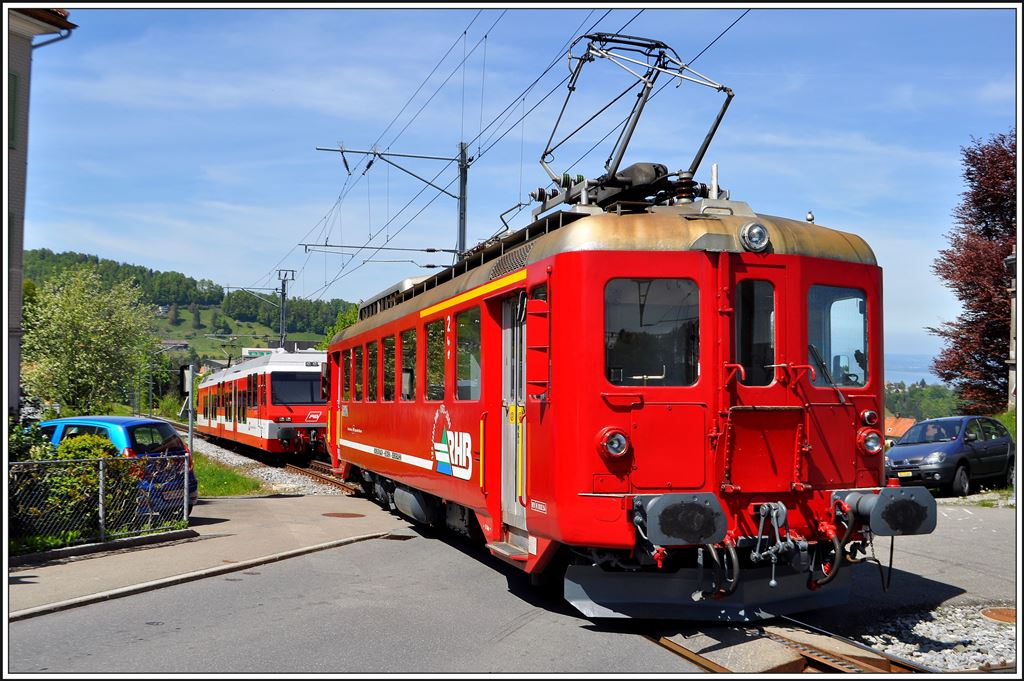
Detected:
left=8, top=537, right=693, bottom=674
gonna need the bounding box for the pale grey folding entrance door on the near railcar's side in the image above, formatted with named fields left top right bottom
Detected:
left=502, top=291, right=526, bottom=548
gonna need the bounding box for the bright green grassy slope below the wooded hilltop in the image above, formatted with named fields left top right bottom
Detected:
left=154, top=305, right=324, bottom=359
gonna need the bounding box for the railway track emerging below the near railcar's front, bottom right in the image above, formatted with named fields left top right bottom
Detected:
left=645, top=618, right=1017, bottom=674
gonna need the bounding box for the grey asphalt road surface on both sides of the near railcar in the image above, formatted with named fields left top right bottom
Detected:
left=8, top=505, right=1020, bottom=674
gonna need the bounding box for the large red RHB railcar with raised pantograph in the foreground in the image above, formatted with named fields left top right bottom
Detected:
left=324, top=34, right=936, bottom=620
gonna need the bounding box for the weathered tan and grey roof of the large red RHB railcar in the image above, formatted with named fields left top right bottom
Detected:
left=331, top=199, right=877, bottom=343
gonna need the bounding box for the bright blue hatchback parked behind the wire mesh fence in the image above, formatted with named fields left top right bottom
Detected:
left=39, top=416, right=199, bottom=513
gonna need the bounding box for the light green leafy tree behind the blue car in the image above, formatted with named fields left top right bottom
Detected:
left=23, top=265, right=158, bottom=413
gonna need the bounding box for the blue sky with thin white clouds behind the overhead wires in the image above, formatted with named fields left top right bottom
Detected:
left=12, top=4, right=1020, bottom=360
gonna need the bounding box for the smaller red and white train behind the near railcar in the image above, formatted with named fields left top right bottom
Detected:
left=196, top=349, right=327, bottom=456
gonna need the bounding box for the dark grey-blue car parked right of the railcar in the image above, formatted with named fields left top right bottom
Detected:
left=886, top=416, right=1016, bottom=497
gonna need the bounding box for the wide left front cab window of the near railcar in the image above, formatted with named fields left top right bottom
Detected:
left=604, top=279, right=700, bottom=386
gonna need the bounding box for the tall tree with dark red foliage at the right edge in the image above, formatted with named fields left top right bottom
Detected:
left=929, top=128, right=1017, bottom=414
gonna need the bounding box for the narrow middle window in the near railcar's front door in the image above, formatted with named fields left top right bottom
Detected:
left=735, top=279, right=775, bottom=385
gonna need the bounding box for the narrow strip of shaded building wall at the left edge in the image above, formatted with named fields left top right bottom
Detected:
left=6, top=27, right=32, bottom=414
